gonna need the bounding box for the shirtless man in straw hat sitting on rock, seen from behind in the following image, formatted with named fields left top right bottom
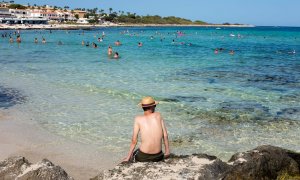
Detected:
left=123, top=97, right=170, bottom=162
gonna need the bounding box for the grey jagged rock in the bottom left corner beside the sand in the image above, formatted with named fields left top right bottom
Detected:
left=0, top=156, right=73, bottom=180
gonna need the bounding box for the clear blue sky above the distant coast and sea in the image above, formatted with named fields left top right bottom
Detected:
left=15, top=0, right=300, bottom=26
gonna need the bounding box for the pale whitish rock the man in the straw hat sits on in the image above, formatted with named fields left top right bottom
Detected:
left=92, top=154, right=230, bottom=180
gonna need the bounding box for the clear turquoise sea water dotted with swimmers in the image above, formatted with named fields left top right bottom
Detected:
left=0, top=27, right=300, bottom=158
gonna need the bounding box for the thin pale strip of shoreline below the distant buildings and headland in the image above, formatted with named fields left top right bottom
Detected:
left=0, top=24, right=255, bottom=30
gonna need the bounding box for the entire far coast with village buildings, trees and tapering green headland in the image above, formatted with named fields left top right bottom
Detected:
left=0, top=0, right=216, bottom=29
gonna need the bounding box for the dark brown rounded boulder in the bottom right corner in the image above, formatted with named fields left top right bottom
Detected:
left=224, top=146, right=300, bottom=180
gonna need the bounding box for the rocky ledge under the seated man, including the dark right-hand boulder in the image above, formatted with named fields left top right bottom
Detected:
left=91, top=146, right=300, bottom=180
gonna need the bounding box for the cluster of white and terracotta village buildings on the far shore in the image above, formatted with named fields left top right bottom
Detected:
left=0, top=1, right=107, bottom=25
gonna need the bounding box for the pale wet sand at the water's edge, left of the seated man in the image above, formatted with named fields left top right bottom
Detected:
left=0, top=109, right=119, bottom=179
